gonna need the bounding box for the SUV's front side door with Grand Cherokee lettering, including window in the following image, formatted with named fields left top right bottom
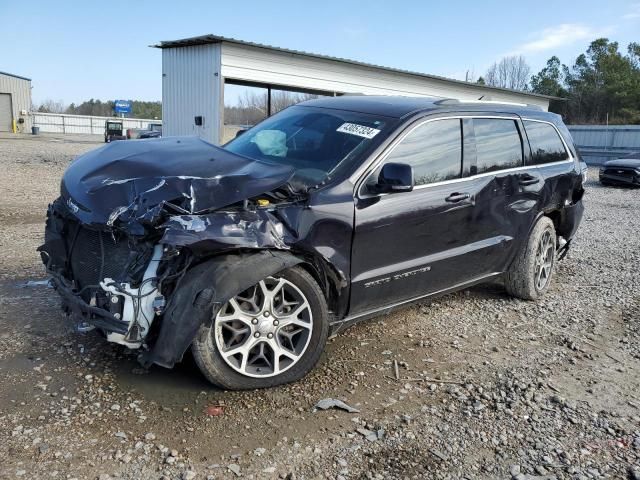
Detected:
left=350, top=118, right=480, bottom=314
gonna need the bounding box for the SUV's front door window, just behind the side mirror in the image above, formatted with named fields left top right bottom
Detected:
left=386, top=119, right=462, bottom=186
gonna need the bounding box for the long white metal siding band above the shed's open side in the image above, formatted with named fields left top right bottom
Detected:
left=221, top=43, right=549, bottom=110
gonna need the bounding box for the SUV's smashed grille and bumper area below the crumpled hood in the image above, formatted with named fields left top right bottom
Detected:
left=39, top=198, right=184, bottom=348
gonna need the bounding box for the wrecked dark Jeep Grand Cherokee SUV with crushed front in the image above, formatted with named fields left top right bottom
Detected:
left=40, top=97, right=583, bottom=389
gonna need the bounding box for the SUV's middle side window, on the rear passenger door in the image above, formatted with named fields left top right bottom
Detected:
left=473, top=118, right=522, bottom=173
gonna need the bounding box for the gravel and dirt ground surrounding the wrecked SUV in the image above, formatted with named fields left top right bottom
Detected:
left=0, top=136, right=640, bottom=480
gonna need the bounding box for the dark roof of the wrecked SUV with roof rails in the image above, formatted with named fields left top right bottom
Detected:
left=297, top=95, right=555, bottom=118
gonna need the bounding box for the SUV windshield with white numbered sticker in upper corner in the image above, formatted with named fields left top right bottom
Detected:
left=224, top=106, right=392, bottom=187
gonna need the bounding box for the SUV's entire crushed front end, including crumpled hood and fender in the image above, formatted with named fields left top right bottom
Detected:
left=38, top=139, right=296, bottom=366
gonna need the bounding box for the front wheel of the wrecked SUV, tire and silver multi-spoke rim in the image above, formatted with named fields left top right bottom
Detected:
left=192, top=267, right=329, bottom=390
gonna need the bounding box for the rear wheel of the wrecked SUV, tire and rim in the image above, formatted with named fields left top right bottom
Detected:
left=504, top=217, right=556, bottom=300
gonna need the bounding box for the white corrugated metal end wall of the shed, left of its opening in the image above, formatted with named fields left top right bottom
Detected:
left=162, top=44, right=222, bottom=143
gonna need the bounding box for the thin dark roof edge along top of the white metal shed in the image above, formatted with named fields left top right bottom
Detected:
left=151, top=34, right=560, bottom=100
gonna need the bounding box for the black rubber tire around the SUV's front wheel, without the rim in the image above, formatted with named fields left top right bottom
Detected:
left=192, top=267, right=329, bottom=390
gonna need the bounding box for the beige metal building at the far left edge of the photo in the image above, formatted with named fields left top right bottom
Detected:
left=0, top=72, right=31, bottom=133
